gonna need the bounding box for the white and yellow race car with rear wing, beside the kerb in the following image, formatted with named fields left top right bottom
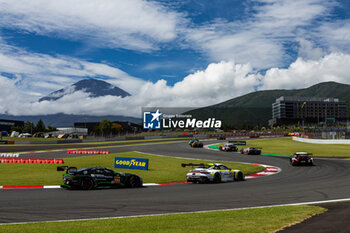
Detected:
left=181, top=163, right=245, bottom=183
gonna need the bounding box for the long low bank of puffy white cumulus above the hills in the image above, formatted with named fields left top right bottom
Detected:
left=0, top=53, right=350, bottom=117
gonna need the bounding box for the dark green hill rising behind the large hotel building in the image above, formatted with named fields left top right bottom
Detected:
left=187, top=82, right=350, bottom=126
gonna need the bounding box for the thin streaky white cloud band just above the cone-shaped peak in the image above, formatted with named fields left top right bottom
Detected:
left=0, top=40, right=145, bottom=97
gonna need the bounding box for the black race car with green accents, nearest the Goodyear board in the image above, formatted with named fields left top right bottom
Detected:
left=57, top=166, right=143, bottom=190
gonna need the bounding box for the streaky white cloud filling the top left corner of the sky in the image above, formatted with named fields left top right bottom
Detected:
left=0, top=0, right=182, bottom=50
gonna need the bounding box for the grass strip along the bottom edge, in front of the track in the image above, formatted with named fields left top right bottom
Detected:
left=0, top=206, right=326, bottom=233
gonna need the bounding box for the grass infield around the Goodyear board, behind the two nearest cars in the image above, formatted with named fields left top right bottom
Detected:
left=0, top=152, right=264, bottom=186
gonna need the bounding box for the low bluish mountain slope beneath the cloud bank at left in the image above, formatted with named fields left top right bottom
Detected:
left=0, top=113, right=141, bottom=128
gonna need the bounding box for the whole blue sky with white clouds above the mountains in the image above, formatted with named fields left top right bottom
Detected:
left=0, top=0, right=350, bottom=115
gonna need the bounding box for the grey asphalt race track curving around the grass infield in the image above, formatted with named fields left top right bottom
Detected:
left=0, top=141, right=350, bottom=229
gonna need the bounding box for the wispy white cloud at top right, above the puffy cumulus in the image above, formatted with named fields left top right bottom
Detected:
left=185, top=0, right=335, bottom=69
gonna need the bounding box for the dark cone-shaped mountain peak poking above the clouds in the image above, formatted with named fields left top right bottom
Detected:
left=39, top=79, right=130, bottom=102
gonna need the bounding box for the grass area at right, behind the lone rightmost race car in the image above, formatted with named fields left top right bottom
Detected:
left=215, top=137, right=350, bottom=157
